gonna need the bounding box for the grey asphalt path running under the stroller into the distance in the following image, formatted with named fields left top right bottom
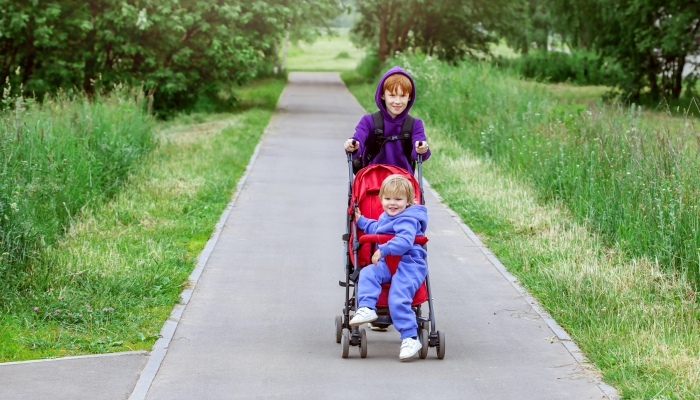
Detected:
left=0, top=73, right=605, bottom=399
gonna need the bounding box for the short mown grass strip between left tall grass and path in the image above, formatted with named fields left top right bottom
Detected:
left=0, top=80, right=284, bottom=361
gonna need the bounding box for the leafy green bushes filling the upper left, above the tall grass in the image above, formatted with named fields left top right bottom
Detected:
left=0, top=0, right=342, bottom=112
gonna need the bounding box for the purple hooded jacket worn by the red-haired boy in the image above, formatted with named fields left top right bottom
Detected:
left=352, top=66, right=430, bottom=173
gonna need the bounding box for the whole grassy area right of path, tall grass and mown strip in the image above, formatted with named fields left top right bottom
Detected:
left=343, top=59, right=700, bottom=398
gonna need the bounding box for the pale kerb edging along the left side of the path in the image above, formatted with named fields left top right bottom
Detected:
left=129, top=115, right=274, bottom=400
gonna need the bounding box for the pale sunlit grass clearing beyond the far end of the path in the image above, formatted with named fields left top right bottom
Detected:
left=287, top=29, right=365, bottom=71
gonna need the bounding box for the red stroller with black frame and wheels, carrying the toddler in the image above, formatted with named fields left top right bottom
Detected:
left=335, top=154, right=445, bottom=359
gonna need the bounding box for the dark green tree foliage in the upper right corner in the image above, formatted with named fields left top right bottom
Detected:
left=549, top=0, right=700, bottom=101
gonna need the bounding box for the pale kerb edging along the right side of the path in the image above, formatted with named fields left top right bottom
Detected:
left=423, top=177, right=620, bottom=400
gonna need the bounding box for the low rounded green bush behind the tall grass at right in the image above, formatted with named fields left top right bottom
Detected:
left=494, top=50, right=623, bottom=85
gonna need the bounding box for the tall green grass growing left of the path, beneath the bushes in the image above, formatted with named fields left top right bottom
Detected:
left=0, top=87, right=153, bottom=288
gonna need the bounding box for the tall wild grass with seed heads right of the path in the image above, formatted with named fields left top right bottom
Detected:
left=400, top=58, right=700, bottom=285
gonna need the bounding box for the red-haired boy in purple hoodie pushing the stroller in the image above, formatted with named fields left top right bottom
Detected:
left=345, top=66, right=430, bottom=172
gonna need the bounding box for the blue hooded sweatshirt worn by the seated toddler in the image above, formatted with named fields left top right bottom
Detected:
left=357, top=205, right=428, bottom=258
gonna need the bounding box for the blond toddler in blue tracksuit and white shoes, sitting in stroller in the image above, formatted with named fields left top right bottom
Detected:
left=350, top=175, right=428, bottom=360
